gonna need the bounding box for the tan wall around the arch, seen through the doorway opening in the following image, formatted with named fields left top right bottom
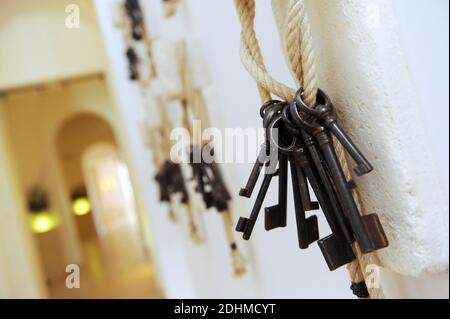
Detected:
left=3, top=79, right=119, bottom=279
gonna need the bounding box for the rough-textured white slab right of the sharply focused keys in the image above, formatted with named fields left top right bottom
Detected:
left=300, top=0, right=448, bottom=275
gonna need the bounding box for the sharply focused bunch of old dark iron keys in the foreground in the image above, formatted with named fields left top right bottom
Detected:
left=236, top=90, right=388, bottom=270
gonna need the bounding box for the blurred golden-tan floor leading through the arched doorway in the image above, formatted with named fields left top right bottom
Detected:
left=49, top=224, right=164, bottom=299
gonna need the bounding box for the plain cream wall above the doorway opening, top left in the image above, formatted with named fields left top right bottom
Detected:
left=0, top=0, right=104, bottom=89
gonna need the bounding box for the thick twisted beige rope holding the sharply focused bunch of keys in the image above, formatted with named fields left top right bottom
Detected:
left=235, top=0, right=384, bottom=298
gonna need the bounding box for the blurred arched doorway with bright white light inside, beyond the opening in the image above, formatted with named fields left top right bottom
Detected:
left=50, top=113, right=159, bottom=298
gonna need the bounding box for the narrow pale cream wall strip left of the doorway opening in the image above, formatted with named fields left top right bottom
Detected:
left=0, top=101, right=46, bottom=298
